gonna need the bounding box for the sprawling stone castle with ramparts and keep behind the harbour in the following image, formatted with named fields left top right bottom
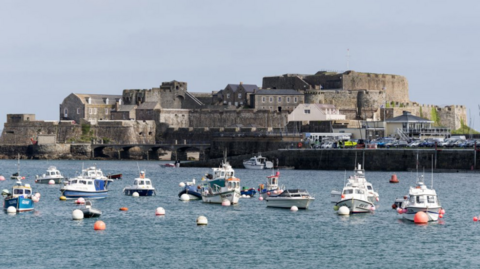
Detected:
left=0, top=68, right=467, bottom=144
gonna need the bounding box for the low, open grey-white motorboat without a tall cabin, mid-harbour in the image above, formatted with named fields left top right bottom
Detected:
left=265, top=189, right=315, bottom=209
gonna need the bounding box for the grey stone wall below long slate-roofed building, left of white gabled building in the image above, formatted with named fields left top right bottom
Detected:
left=189, top=109, right=288, bottom=128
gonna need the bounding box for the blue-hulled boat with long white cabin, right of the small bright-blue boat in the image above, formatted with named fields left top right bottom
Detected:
left=60, top=167, right=113, bottom=199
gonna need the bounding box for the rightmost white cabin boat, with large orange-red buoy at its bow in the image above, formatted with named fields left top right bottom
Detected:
left=401, top=176, right=442, bottom=221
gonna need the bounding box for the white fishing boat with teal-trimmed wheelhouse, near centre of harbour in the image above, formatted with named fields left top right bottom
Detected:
left=202, top=161, right=240, bottom=204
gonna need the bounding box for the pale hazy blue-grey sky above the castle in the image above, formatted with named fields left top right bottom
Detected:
left=0, top=0, right=480, bottom=130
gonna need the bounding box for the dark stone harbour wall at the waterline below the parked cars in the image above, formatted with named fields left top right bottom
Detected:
left=182, top=149, right=480, bottom=172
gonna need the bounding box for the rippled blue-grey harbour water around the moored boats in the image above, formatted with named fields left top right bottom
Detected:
left=0, top=160, right=480, bottom=268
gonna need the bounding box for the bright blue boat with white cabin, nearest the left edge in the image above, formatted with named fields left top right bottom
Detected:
left=3, top=181, right=33, bottom=212
